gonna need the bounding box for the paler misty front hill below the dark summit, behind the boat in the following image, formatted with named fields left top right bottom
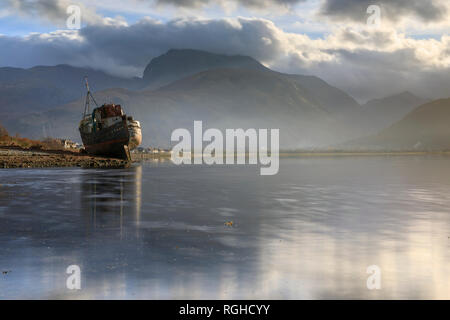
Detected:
left=15, top=69, right=346, bottom=148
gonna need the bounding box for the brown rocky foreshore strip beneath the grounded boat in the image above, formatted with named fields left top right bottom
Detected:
left=0, top=148, right=130, bottom=168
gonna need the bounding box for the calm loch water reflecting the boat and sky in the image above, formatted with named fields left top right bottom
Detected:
left=0, top=156, right=450, bottom=299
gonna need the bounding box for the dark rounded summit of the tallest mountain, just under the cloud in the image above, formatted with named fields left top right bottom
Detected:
left=143, top=49, right=269, bottom=88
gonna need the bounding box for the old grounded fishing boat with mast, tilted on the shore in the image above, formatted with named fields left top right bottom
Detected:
left=79, top=78, right=142, bottom=160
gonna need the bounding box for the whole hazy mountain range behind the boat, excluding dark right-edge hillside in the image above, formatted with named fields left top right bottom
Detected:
left=0, top=49, right=446, bottom=149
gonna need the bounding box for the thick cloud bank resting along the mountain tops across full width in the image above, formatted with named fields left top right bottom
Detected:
left=0, top=0, right=450, bottom=100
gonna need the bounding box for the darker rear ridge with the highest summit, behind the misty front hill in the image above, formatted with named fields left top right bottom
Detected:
left=0, top=49, right=357, bottom=119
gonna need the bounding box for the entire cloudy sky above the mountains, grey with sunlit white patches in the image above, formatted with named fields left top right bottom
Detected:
left=0, top=0, right=450, bottom=99
